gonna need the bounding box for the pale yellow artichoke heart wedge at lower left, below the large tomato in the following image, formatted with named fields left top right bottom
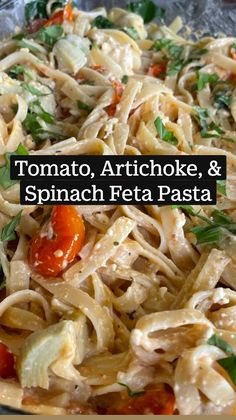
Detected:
left=17, top=321, right=81, bottom=389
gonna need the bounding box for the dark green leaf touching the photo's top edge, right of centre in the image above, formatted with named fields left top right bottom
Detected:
left=127, top=0, right=165, bottom=23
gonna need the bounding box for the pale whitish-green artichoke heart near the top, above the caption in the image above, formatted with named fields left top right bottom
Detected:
left=53, top=34, right=90, bottom=74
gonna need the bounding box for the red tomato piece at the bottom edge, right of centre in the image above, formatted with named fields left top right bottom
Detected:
left=106, top=387, right=175, bottom=414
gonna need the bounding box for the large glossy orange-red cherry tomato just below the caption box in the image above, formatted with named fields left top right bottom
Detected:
left=28, top=205, right=85, bottom=277
